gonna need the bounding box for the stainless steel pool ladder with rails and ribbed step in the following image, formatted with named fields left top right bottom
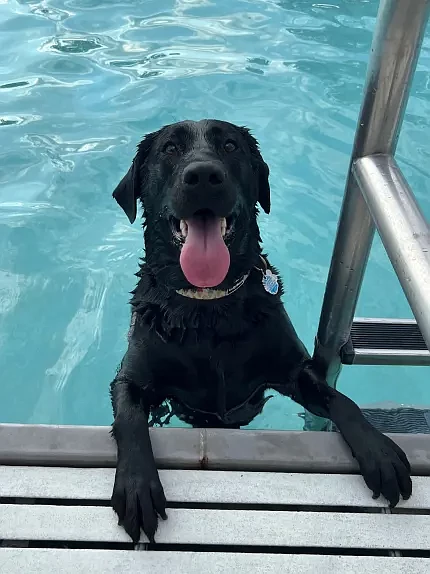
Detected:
left=305, top=0, right=430, bottom=430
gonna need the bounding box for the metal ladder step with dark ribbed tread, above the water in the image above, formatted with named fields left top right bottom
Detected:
left=341, top=318, right=430, bottom=366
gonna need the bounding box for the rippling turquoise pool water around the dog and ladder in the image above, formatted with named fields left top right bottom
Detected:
left=0, top=0, right=430, bottom=429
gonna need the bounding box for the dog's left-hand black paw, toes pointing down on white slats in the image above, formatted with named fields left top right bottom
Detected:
left=111, top=462, right=167, bottom=544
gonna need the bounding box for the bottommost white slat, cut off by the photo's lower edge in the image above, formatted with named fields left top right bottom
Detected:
left=0, top=549, right=429, bottom=574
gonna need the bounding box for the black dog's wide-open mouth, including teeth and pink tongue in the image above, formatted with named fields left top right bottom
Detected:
left=170, top=209, right=235, bottom=288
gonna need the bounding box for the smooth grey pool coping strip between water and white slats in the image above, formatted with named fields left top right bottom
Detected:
left=0, top=424, right=430, bottom=475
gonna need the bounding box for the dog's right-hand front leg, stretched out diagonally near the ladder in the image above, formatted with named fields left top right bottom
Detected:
left=290, top=360, right=412, bottom=507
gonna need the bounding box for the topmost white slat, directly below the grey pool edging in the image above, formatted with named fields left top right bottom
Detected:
left=0, top=468, right=430, bottom=508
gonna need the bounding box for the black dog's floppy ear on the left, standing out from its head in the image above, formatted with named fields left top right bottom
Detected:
left=112, top=132, right=158, bottom=223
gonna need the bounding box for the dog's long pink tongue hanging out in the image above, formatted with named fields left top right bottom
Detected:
left=180, top=217, right=230, bottom=287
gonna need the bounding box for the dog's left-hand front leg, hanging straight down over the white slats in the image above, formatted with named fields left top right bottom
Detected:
left=111, top=373, right=167, bottom=543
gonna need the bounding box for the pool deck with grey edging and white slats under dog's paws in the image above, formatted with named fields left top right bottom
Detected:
left=0, top=425, right=430, bottom=574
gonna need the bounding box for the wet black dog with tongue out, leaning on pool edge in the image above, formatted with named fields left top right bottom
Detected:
left=111, top=120, right=412, bottom=542
